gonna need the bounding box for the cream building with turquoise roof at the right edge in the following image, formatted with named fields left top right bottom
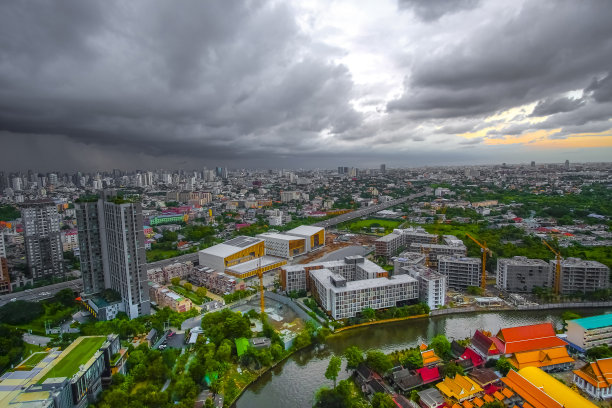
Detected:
left=567, top=314, right=612, bottom=352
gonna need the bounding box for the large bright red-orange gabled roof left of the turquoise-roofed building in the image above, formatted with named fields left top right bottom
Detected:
left=497, top=323, right=567, bottom=354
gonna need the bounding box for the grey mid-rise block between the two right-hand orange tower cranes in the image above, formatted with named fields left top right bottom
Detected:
left=495, top=256, right=552, bottom=293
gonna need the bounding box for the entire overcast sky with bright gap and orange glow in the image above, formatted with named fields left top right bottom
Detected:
left=0, top=0, right=612, bottom=171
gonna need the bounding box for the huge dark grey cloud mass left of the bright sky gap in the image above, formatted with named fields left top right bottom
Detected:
left=0, top=1, right=361, bottom=169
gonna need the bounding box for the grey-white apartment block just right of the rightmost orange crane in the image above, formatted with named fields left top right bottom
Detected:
left=549, top=258, right=610, bottom=295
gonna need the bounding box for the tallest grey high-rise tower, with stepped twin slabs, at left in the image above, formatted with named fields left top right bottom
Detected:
left=76, top=192, right=150, bottom=319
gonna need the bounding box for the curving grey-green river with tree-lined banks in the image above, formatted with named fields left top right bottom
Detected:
left=235, top=309, right=606, bottom=408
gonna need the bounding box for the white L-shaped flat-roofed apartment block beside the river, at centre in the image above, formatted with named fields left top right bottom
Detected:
left=310, top=268, right=419, bottom=320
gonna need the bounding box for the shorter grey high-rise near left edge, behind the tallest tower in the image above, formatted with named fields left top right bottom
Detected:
left=21, top=200, right=65, bottom=279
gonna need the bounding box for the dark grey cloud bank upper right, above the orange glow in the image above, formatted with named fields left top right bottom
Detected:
left=388, top=1, right=612, bottom=119
